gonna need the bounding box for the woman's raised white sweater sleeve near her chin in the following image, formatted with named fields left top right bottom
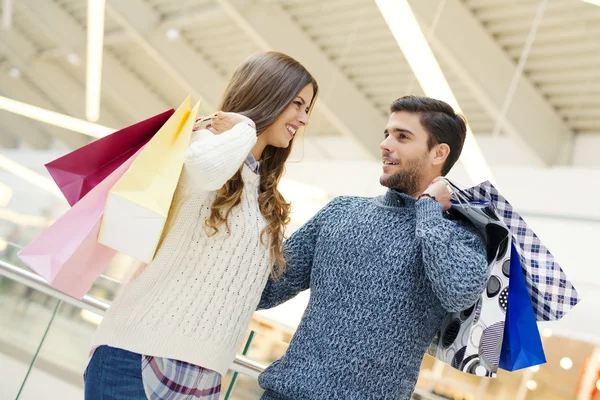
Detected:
left=184, top=123, right=256, bottom=190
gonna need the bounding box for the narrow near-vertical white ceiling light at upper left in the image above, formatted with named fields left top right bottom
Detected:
left=85, top=0, right=106, bottom=122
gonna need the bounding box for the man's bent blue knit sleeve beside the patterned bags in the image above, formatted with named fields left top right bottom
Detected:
left=416, top=199, right=489, bottom=312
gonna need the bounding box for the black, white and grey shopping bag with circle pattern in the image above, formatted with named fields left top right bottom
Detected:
left=428, top=201, right=511, bottom=377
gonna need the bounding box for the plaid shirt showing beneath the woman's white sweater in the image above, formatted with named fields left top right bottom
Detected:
left=89, top=153, right=260, bottom=400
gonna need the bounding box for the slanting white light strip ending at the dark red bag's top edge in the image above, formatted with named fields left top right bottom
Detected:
left=0, top=96, right=115, bottom=138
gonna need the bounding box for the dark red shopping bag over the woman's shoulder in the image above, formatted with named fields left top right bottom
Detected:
left=46, top=109, right=175, bottom=206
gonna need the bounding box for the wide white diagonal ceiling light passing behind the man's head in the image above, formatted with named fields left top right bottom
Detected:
left=375, top=0, right=494, bottom=183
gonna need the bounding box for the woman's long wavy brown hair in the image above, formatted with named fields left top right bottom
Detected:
left=205, top=51, right=318, bottom=277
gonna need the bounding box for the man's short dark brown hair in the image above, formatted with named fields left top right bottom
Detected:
left=390, top=96, right=467, bottom=175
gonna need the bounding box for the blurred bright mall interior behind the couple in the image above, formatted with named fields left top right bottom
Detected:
left=0, top=0, right=600, bottom=400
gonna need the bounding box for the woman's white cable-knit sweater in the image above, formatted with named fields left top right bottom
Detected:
left=92, top=123, right=270, bottom=376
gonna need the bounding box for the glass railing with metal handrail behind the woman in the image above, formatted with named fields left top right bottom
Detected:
left=0, top=252, right=264, bottom=400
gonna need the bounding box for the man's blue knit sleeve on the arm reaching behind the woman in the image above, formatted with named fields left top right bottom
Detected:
left=258, top=199, right=337, bottom=309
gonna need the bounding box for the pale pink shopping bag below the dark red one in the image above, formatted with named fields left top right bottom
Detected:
left=18, top=150, right=139, bottom=299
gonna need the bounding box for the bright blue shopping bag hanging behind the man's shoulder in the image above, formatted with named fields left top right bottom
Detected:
left=499, top=244, right=546, bottom=371
